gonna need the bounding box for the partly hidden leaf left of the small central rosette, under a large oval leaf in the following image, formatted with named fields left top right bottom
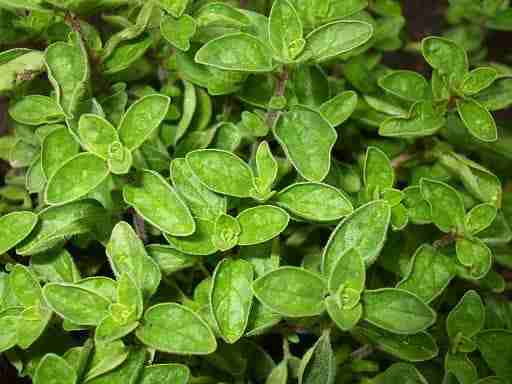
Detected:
left=164, top=218, right=218, bottom=256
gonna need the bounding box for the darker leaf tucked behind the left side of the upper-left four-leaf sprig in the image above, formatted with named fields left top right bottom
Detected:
left=41, top=125, right=80, bottom=178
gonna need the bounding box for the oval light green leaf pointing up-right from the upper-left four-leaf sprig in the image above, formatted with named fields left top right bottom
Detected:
left=118, top=94, right=171, bottom=151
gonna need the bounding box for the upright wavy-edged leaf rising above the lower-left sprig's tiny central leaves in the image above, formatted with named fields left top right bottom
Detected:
left=106, top=221, right=161, bottom=300
